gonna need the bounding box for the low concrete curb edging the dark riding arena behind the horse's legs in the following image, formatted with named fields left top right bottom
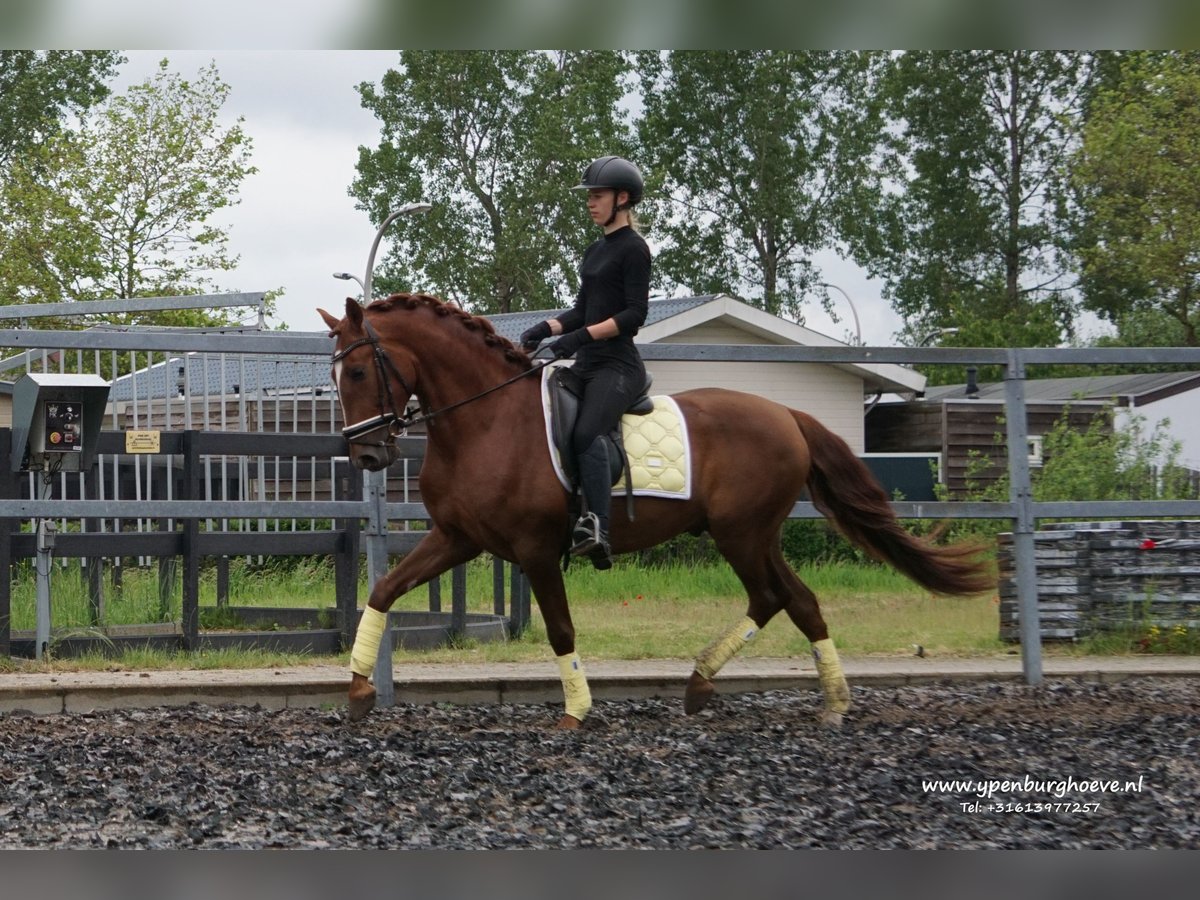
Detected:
left=0, top=656, right=1200, bottom=715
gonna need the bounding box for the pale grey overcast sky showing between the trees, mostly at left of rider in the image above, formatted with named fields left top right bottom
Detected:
left=114, top=50, right=901, bottom=346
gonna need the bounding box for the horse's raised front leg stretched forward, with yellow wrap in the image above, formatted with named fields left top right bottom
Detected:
left=349, top=527, right=480, bottom=721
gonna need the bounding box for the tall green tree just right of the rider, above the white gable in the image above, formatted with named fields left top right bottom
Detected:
left=638, top=50, right=881, bottom=318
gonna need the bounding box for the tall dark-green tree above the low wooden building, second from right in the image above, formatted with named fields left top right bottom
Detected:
left=862, top=50, right=1094, bottom=355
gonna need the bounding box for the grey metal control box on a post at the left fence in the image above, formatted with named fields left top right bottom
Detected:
left=12, top=372, right=109, bottom=472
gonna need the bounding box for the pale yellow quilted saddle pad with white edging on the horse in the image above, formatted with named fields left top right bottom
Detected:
left=541, top=373, right=691, bottom=500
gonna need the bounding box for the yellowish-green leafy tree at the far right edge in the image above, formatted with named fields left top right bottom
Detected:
left=1072, top=53, right=1200, bottom=347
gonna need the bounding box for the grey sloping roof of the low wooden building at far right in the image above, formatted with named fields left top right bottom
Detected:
left=922, top=372, right=1200, bottom=407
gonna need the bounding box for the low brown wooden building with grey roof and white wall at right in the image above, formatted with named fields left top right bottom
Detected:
left=865, top=372, right=1200, bottom=494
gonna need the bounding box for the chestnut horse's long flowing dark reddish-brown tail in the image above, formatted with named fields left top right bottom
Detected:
left=791, top=409, right=996, bottom=595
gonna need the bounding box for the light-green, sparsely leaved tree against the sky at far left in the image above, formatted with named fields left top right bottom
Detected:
left=0, top=60, right=256, bottom=324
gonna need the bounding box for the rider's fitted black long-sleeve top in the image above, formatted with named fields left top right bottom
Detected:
left=558, top=226, right=650, bottom=368
